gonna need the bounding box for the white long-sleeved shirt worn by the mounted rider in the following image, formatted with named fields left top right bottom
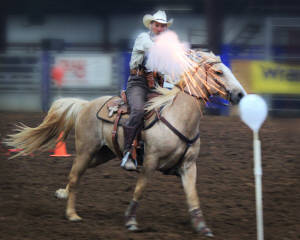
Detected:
left=129, top=32, right=153, bottom=69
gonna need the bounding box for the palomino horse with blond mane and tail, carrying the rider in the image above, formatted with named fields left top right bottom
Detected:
left=7, top=53, right=246, bottom=236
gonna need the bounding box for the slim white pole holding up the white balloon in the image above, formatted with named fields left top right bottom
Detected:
left=253, top=131, right=264, bottom=240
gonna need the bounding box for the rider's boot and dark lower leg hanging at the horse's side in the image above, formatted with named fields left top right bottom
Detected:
left=121, top=126, right=137, bottom=171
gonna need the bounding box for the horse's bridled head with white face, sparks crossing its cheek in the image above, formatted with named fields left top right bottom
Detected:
left=180, top=51, right=247, bottom=104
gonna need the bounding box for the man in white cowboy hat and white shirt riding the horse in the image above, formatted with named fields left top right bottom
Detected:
left=121, top=10, right=173, bottom=170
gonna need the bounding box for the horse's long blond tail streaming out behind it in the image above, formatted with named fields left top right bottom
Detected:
left=4, top=98, right=88, bottom=158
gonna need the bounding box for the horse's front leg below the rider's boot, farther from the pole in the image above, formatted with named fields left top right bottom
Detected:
left=125, top=158, right=155, bottom=231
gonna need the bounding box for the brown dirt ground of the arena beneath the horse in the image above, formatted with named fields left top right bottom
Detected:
left=0, top=112, right=300, bottom=240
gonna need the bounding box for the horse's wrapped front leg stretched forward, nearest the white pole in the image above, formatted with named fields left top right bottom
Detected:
left=181, top=161, right=213, bottom=237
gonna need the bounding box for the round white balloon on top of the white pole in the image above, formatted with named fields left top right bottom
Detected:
left=239, top=94, right=268, bottom=132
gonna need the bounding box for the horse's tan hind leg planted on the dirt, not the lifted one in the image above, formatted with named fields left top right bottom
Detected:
left=66, top=153, right=91, bottom=221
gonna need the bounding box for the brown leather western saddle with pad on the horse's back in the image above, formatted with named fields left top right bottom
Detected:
left=97, top=91, right=158, bottom=164
